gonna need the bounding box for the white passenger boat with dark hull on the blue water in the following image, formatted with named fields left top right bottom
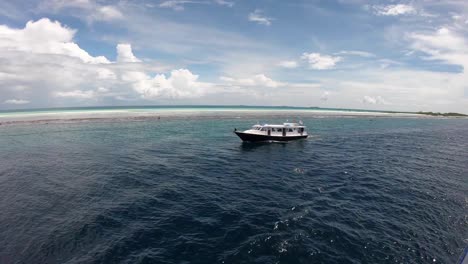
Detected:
left=234, top=121, right=308, bottom=142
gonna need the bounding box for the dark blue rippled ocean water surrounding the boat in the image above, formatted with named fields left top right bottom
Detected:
left=0, top=116, right=468, bottom=263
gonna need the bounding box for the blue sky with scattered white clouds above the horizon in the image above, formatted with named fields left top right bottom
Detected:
left=0, top=0, right=468, bottom=113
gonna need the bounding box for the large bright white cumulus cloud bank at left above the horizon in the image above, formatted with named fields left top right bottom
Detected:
left=0, top=18, right=220, bottom=106
